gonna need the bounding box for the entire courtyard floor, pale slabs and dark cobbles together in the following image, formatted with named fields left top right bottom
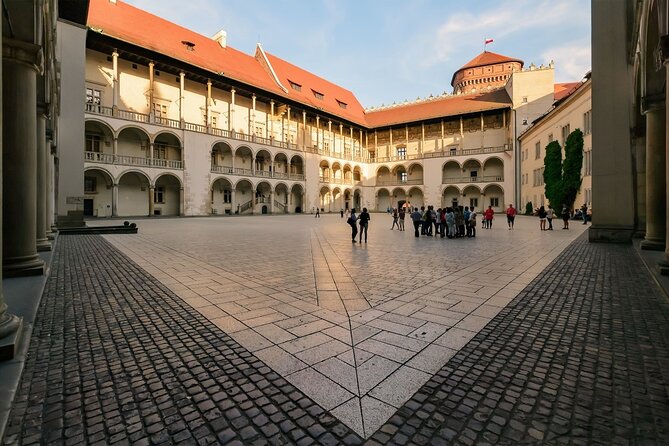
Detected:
left=4, top=214, right=669, bottom=445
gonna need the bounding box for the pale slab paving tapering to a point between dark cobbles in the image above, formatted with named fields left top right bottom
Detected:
left=99, top=214, right=583, bottom=438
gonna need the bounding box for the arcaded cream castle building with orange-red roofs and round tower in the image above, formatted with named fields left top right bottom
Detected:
left=59, top=0, right=568, bottom=220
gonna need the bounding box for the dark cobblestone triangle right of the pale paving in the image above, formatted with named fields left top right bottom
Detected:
left=369, top=236, right=669, bottom=445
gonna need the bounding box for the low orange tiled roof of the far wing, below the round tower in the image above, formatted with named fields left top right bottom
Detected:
left=360, top=88, right=511, bottom=127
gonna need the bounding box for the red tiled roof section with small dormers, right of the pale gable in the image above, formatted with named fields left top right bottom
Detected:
left=265, top=53, right=366, bottom=125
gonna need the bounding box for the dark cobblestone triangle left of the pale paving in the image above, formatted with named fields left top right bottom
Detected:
left=4, top=236, right=362, bottom=445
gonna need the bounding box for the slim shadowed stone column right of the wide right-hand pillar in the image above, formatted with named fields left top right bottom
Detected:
left=641, top=98, right=667, bottom=251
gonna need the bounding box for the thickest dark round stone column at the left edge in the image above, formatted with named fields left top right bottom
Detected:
left=2, top=38, right=44, bottom=277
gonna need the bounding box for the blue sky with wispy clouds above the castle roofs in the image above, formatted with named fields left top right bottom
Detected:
left=122, top=0, right=591, bottom=107
